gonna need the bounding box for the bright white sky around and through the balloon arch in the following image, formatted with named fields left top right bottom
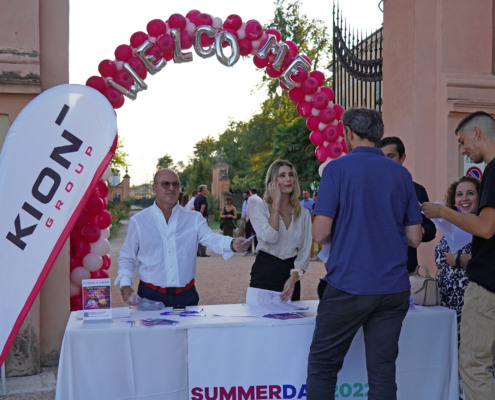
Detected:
left=69, top=0, right=383, bottom=185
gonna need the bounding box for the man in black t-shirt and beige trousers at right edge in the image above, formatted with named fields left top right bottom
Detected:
left=421, top=111, right=495, bottom=400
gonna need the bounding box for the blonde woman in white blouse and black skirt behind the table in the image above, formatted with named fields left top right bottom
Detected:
left=250, top=160, right=312, bottom=301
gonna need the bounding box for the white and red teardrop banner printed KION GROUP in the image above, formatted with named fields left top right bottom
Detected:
left=0, top=85, right=117, bottom=365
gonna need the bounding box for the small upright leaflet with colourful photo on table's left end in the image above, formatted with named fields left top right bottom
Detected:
left=82, top=278, right=112, bottom=321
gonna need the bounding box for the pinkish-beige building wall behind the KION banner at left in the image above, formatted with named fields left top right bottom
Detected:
left=0, top=0, right=70, bottom=376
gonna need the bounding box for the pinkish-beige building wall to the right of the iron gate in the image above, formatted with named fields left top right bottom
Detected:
left=383, top=0, right=495, bottom=273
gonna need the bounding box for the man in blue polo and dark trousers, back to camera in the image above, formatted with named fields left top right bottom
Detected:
left=307, top=108, right=422, bottom=400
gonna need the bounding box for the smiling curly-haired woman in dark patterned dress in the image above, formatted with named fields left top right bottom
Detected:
left=435, top=176, right=480, bottom=340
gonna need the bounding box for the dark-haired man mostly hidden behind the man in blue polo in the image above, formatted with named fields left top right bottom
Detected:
left=376, top=136, right=437, bottom=274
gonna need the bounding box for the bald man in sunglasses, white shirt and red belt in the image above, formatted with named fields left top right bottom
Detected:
left=115, top=168, right=249, bottom=306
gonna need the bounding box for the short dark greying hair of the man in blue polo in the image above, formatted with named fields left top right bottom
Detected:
left=342, top=108, right=383, bottom=143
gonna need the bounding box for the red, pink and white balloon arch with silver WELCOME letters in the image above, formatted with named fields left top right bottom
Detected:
left=70, top=10, right=348, bottom=311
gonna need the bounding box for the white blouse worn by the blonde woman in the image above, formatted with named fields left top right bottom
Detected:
left=251, top=201, right=313, bottom=271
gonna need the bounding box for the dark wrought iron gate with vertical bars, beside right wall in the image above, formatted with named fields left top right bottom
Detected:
left=327, top=3, right=383, bottom=112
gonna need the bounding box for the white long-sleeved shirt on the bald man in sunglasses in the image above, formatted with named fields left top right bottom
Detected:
left=115, top=203, right=234, bottom=287
